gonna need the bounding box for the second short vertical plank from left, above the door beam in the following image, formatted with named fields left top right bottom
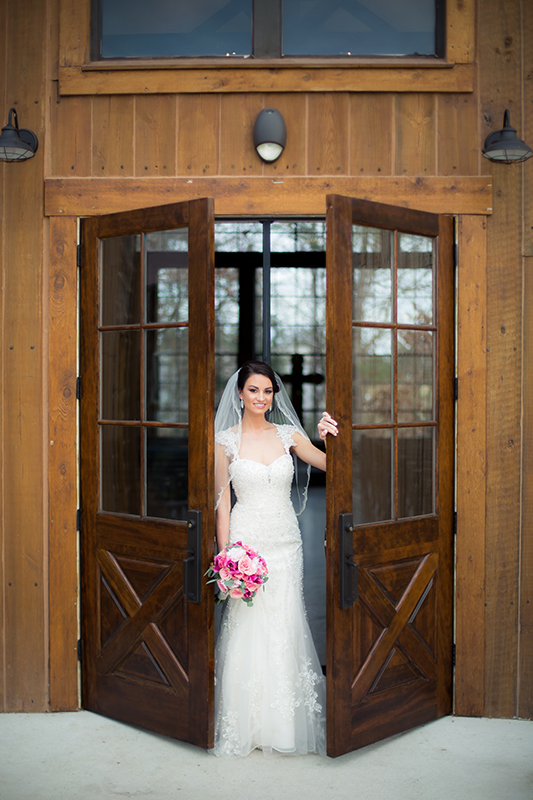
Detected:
left=92, top=95, right=135, bottom=178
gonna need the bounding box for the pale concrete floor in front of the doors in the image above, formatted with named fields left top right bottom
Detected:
left=0, top=711, right=533, bottom=800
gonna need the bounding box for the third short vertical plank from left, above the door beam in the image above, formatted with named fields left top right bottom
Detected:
left=135, top=94, right=176, bottom=178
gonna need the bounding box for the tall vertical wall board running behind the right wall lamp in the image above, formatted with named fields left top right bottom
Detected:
left=479, top=0, right=522, bottom=717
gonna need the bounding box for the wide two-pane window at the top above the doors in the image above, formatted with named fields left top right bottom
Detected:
left=92, top=0, right=444, bottom=59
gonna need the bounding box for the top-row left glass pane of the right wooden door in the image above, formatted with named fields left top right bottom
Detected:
left=352, top=225, right=393, bottom=322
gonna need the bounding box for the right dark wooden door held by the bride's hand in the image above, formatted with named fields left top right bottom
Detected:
left=327, top=196, right=453, bottom=756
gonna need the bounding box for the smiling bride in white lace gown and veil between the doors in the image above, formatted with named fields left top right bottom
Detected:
left=212, top=362, right=337, bottom=756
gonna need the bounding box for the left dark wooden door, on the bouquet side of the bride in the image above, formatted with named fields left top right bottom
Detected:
left=80, top=200, right=214, bottom=747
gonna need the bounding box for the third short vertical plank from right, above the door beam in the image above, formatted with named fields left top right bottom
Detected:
left=350, top=92, right=394, bottom=175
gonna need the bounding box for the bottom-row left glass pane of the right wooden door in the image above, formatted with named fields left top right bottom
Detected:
left=352, top=429, right=393, bottom=525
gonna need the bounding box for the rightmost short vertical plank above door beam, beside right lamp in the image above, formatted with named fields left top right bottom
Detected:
left=437, top=94, right=480, bottom=175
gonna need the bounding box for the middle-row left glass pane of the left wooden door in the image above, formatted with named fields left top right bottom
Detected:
left=100, top=330, right=141, bottom=420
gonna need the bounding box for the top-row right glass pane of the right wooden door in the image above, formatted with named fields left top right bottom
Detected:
left=398, top=233, right=435, bottom=325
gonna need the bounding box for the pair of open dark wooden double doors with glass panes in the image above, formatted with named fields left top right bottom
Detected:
left=80, top=196, right=453, bottom=756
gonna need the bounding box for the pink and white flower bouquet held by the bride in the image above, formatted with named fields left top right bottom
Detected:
left=205, top=542, right=268, bottom=606
